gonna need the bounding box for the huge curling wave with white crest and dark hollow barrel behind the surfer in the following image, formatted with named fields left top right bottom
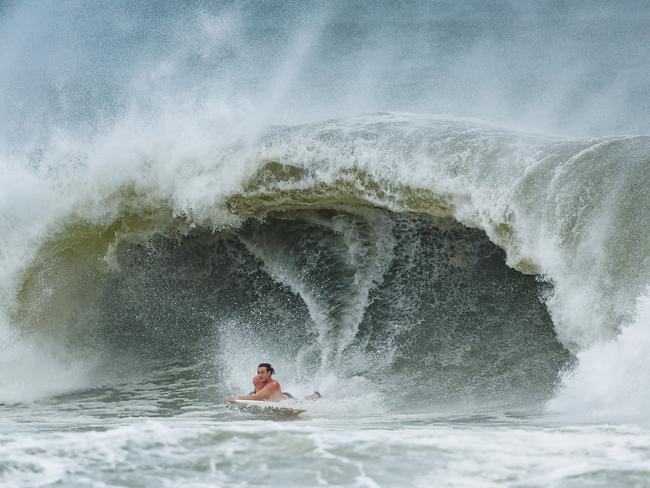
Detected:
left=0, top=113, right=650, bottom=417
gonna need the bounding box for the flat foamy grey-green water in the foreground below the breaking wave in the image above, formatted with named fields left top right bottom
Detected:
left=0, top=364, right=650, bottom=487
